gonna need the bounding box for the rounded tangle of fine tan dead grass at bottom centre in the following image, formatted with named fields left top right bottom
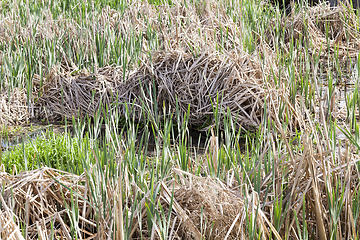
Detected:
left=132, top=172, right=253, bottom=240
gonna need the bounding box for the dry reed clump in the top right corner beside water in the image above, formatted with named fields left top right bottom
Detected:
left=268, top=3, right=360, bottom=54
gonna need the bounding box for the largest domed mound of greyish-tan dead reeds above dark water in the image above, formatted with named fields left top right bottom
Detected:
left=121, top=49, right=272, bottom=126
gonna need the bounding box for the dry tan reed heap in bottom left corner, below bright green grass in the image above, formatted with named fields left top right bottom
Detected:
left=0, top=168, right=97, bottom=239
